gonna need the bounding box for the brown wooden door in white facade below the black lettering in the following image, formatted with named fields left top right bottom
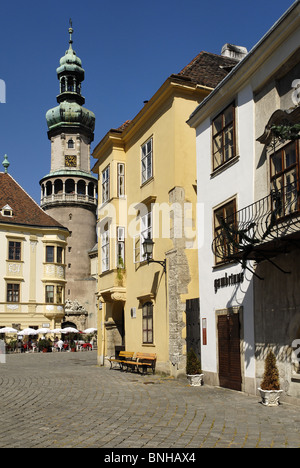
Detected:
left=218, top=314, right=242, bottom=391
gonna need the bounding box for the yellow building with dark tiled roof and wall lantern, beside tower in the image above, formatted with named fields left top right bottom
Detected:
left=93, top=48, right=237, bottom=376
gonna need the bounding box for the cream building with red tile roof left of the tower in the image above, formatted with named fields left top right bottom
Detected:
left=0, top=168, right=69, bottom=330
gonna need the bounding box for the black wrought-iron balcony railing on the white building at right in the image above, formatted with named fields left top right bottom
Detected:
left=212, top=180, right=300, bottom=267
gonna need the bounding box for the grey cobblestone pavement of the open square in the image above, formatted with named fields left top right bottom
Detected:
left=0, top=351, right=300, bottom=450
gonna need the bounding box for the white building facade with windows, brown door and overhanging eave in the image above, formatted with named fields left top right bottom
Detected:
left=188, top=1, right=300, bottom=400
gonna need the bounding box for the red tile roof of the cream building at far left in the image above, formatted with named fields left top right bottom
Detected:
left=0, top=172, right=67, bottom=229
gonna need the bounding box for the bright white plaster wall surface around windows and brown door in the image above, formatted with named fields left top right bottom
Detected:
left=197, top=84, right=255, bottom=392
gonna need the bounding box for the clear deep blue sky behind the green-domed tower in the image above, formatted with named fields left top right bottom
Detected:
left=0, top=0, right=293, bottom=203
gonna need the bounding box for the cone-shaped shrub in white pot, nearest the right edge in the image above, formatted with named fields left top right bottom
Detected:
left=258, top=351, right=282, bottom=406
